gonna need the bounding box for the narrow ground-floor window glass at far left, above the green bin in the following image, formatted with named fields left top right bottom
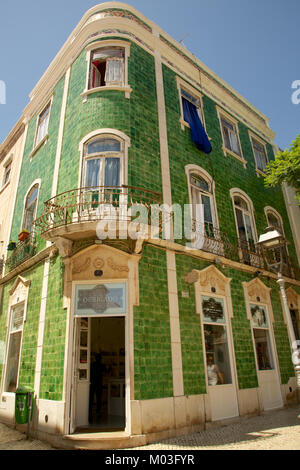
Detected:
left=4, top=302, right=25, bottom=393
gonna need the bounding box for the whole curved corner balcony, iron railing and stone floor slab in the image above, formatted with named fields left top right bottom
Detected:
left=34, top=185, right=162, bottom=241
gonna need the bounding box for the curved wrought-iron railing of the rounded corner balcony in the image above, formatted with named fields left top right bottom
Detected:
left=34, top=185, right=162, bottom=234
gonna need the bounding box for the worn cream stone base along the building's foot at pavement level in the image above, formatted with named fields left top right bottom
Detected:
left=0, top=388, right=297, bottom=449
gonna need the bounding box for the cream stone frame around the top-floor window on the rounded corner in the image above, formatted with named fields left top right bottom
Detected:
left=81, top=39, right=132, bottom=103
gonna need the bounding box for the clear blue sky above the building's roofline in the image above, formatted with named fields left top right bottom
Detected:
left=0, top=0, right=300, bottom=148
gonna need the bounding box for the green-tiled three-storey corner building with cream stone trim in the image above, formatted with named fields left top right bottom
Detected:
left=0, top=2, right=300, bottom=448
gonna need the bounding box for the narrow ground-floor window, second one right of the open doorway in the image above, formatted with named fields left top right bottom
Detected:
left=250, top=304, right=274, bottom=370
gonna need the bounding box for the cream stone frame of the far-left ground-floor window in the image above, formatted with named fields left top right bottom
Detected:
left=0, top=276, right=31, bottom=400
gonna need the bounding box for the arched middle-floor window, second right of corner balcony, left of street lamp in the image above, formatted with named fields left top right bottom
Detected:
left=232, top=193, right=256, bottom=265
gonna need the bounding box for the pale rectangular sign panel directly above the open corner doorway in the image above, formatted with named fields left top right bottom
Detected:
left=74, top=282, right=127, bottom=317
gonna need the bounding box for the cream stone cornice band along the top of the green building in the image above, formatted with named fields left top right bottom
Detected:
left=17, top=2, right=275, bottom=142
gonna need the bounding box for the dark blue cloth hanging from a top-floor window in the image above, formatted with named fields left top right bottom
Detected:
left=182, top=98, right=212, bottom=153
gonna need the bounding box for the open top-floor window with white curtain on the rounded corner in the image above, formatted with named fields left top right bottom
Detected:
left=89, top=47, right=125, bottom=89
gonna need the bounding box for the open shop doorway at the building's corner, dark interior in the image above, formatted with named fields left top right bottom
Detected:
left=73, top=317, right=126, bottom=432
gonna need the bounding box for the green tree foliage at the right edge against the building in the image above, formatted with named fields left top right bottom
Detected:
left=265, top=134, right=300, bottom=204
